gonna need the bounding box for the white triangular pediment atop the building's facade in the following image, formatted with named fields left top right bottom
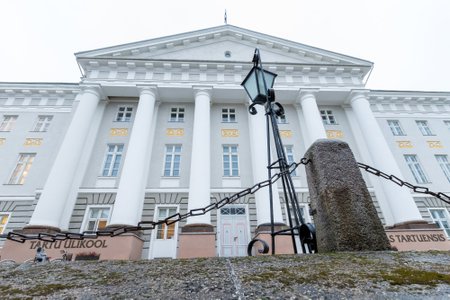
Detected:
left=76, top=25, right=372, bottom=66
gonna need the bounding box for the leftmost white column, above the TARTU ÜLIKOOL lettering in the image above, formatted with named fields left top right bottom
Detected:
left=29, top=87, right=100, bottom=228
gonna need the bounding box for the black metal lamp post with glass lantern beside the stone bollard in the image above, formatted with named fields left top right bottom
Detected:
left=241, top=49, right=317, bottom=254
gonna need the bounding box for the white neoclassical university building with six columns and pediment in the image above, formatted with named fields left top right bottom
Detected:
left=0, top=25, right=450, bottom=260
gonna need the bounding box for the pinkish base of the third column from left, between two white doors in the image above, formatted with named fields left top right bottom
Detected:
left=177, top=224, right=216, bottom=258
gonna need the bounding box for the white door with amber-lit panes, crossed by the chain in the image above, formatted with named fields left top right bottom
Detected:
left=151, top=207, right=178, bottom=258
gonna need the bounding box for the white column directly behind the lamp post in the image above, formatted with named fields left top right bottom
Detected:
left=249, top=105, right=284, bottom=226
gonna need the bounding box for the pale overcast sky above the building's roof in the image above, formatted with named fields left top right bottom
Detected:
left=0, top=0, right=450, bottom=91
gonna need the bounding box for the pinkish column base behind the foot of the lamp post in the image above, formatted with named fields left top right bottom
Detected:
left=254, top=223, right=294, bottom=255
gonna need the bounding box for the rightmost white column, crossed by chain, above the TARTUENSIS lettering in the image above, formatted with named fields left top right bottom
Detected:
left=350, top=92, right=423, bottom=224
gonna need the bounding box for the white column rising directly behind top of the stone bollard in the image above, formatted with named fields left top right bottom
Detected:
left=299, top=91, right=327, bottom=148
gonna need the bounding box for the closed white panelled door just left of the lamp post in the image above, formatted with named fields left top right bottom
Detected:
left=220, top=205, right=248, bottom=257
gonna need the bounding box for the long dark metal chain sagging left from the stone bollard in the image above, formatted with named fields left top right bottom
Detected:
left=0, top=158, right=310, bottom=243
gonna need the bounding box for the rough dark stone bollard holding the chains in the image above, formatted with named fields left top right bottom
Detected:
left=305, top=139, right=390, bottom=252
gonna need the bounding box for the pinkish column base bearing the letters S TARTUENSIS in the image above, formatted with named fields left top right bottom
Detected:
left=385, top=221, right=450, bottom=251
